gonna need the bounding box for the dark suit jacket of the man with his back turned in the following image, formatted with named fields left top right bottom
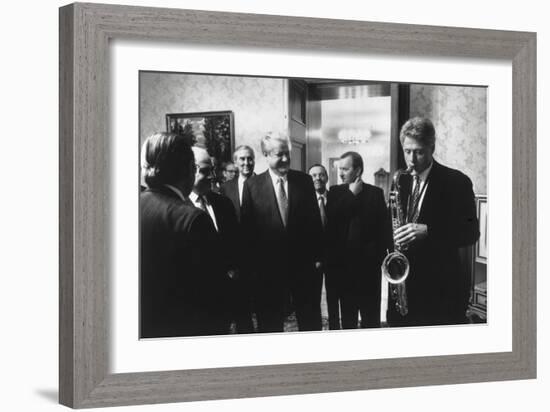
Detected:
left=140, top=188, right=223, bottom=337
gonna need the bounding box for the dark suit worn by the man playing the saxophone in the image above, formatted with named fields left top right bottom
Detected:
left=401, top=161, right=479, bottom=324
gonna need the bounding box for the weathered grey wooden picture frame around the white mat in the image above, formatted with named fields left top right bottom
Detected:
left=59, top=3, right=536, bottom=408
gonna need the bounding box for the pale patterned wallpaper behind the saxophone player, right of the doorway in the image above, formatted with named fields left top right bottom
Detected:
left=410, top=85, right=487, bottom=194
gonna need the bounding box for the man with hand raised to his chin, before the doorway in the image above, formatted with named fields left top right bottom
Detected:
left=328, top=152, right=391, bottom=329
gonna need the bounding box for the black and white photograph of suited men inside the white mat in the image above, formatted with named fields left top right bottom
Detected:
left=140, top=71, right=489, bottom=339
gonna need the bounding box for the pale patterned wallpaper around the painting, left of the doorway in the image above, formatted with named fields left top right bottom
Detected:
left=140, top=72, right=288, bottom=172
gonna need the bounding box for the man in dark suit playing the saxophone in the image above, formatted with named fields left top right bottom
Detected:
left=388, top=117, right=479, bottom=326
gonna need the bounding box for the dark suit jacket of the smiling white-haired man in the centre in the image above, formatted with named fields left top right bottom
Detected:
left=241, top=170, right=323, bottom=280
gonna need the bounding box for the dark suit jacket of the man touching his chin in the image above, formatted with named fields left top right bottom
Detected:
left=327, top=183, right=391, bottom=284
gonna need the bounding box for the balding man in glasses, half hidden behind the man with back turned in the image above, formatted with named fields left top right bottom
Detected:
left=189, top=146, right=253, bottom=333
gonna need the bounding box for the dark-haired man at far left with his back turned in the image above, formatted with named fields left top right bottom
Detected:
left=139, top=133, right=222, bottom=338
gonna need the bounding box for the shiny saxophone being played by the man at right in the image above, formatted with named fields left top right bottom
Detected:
left=382, top=167, right=412, bottom=316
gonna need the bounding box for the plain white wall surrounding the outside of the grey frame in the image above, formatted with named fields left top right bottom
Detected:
left=0, top=0, right=550, bottom=412
